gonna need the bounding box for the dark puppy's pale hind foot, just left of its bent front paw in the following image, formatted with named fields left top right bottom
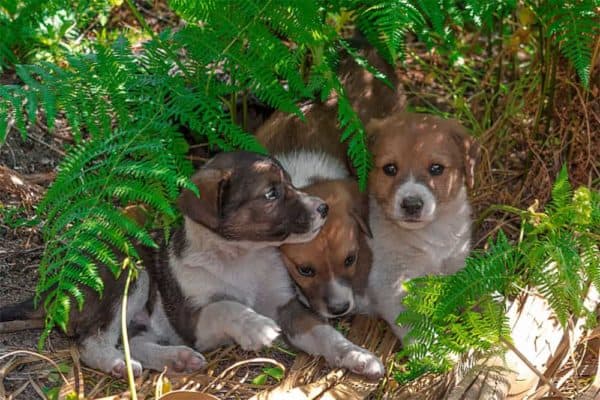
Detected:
left=130, top=331, right=206, bottom=372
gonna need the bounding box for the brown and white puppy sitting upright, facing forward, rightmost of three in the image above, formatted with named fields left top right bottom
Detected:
left=359, top=113, right=479, bottom=338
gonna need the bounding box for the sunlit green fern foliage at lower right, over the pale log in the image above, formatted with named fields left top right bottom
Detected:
left=396, top=168, right=600, bottom=382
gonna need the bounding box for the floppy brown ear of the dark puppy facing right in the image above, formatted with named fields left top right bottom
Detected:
left=177, top=167, right=231, bottom=230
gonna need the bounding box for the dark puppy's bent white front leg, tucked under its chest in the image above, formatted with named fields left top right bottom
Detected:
left=194, top=300, right=280, bottom=351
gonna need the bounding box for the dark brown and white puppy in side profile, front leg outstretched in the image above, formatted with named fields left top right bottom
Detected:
left=131, top=152, right=383, bottom=378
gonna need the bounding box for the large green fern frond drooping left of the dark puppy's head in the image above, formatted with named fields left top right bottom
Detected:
left=37, top=130, right=191, bottom=338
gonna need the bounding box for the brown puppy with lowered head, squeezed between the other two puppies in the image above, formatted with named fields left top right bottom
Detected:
left=275, top=150, right=372, bottom=318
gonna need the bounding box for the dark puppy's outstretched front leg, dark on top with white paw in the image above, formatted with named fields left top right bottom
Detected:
left=278, top=299, right=385, bottom=379
